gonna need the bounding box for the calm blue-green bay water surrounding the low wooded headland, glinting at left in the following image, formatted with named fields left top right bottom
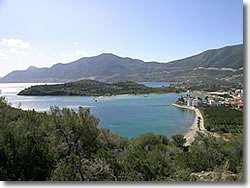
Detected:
left=0, top=83, right=194, bottom=138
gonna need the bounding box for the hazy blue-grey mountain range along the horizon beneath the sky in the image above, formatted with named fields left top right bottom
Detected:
left=0, top=44, right=243, bottom=82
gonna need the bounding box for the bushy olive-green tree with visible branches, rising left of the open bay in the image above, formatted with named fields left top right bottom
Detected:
left=51, top=107, right=100, bottom=158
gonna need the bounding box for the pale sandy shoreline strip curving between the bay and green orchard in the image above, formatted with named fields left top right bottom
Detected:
left=171, top=104, right=206, bottom=146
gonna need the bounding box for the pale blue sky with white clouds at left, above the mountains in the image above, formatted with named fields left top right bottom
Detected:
left=0, top=0, right=243, bottom=77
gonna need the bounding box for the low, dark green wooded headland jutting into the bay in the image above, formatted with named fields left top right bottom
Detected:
left=18, top=80, right=182, bottom=97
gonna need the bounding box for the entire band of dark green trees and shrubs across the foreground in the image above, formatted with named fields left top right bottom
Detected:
left=0, top=99, right=243, bottom=181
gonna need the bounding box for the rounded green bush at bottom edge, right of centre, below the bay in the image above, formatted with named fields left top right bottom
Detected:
left=123, top=133, right=173, bottom=181
